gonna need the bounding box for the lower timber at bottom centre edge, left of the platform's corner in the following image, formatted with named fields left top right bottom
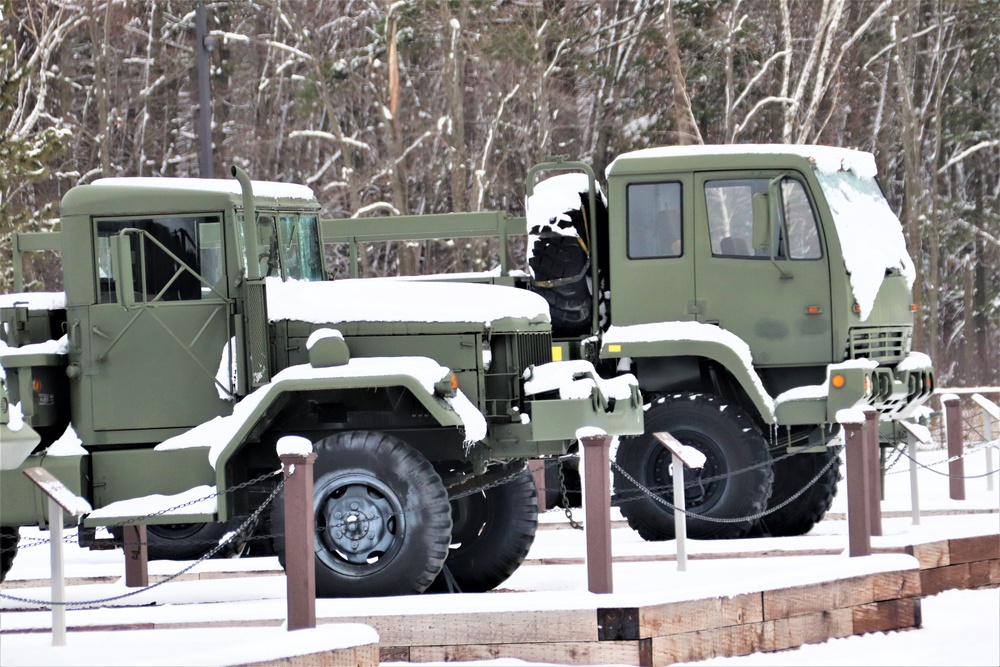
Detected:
left=409, top=641, right=648, bottom=665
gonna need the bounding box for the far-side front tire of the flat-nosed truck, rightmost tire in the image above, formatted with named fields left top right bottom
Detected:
left=753, top=447, right=843, bottom=537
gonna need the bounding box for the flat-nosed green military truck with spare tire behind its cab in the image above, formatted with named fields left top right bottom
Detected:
left=322, top=145, right=934, bottom=540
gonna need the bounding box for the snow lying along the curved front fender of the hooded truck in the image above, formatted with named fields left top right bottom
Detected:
left=155, top=357, right=486, bottom=467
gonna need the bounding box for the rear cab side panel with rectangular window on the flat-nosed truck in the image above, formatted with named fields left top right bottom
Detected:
left=610, top=175, right=695, bottom=325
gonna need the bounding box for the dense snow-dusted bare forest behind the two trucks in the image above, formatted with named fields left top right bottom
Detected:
left=0, top=0, right=1000, bottom=386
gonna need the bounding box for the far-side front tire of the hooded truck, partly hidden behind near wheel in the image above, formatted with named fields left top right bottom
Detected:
left=431, top=469, right=538, bottom=593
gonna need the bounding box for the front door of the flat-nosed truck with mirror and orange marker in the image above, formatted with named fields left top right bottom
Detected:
left=695, top=173, right=833, bottom=366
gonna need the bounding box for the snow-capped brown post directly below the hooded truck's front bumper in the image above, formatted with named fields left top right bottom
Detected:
left=580, top=435, right=614, bottom=593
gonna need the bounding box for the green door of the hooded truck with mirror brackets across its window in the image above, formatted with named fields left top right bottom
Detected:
left=87, top=215, right=232, bottom=431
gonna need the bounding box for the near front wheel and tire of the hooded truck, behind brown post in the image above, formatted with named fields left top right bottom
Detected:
left=271, top=431, right=452, bottom=597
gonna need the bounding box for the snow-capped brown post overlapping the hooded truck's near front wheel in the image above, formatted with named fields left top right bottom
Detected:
left=279, top=444, right=316, bottom=630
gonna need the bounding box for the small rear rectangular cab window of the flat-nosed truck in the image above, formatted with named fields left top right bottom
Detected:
left=627, top=183, right=683, bottom=259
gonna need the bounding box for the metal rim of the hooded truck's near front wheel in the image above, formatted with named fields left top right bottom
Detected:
left=314, top=475, right=406, bottom=575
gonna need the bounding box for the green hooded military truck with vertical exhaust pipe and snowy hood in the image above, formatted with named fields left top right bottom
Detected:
left=0, top=168, right=642, bottom=596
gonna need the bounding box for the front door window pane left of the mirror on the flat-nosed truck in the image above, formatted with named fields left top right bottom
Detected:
left=705, top=178, right=767, bottom=257
